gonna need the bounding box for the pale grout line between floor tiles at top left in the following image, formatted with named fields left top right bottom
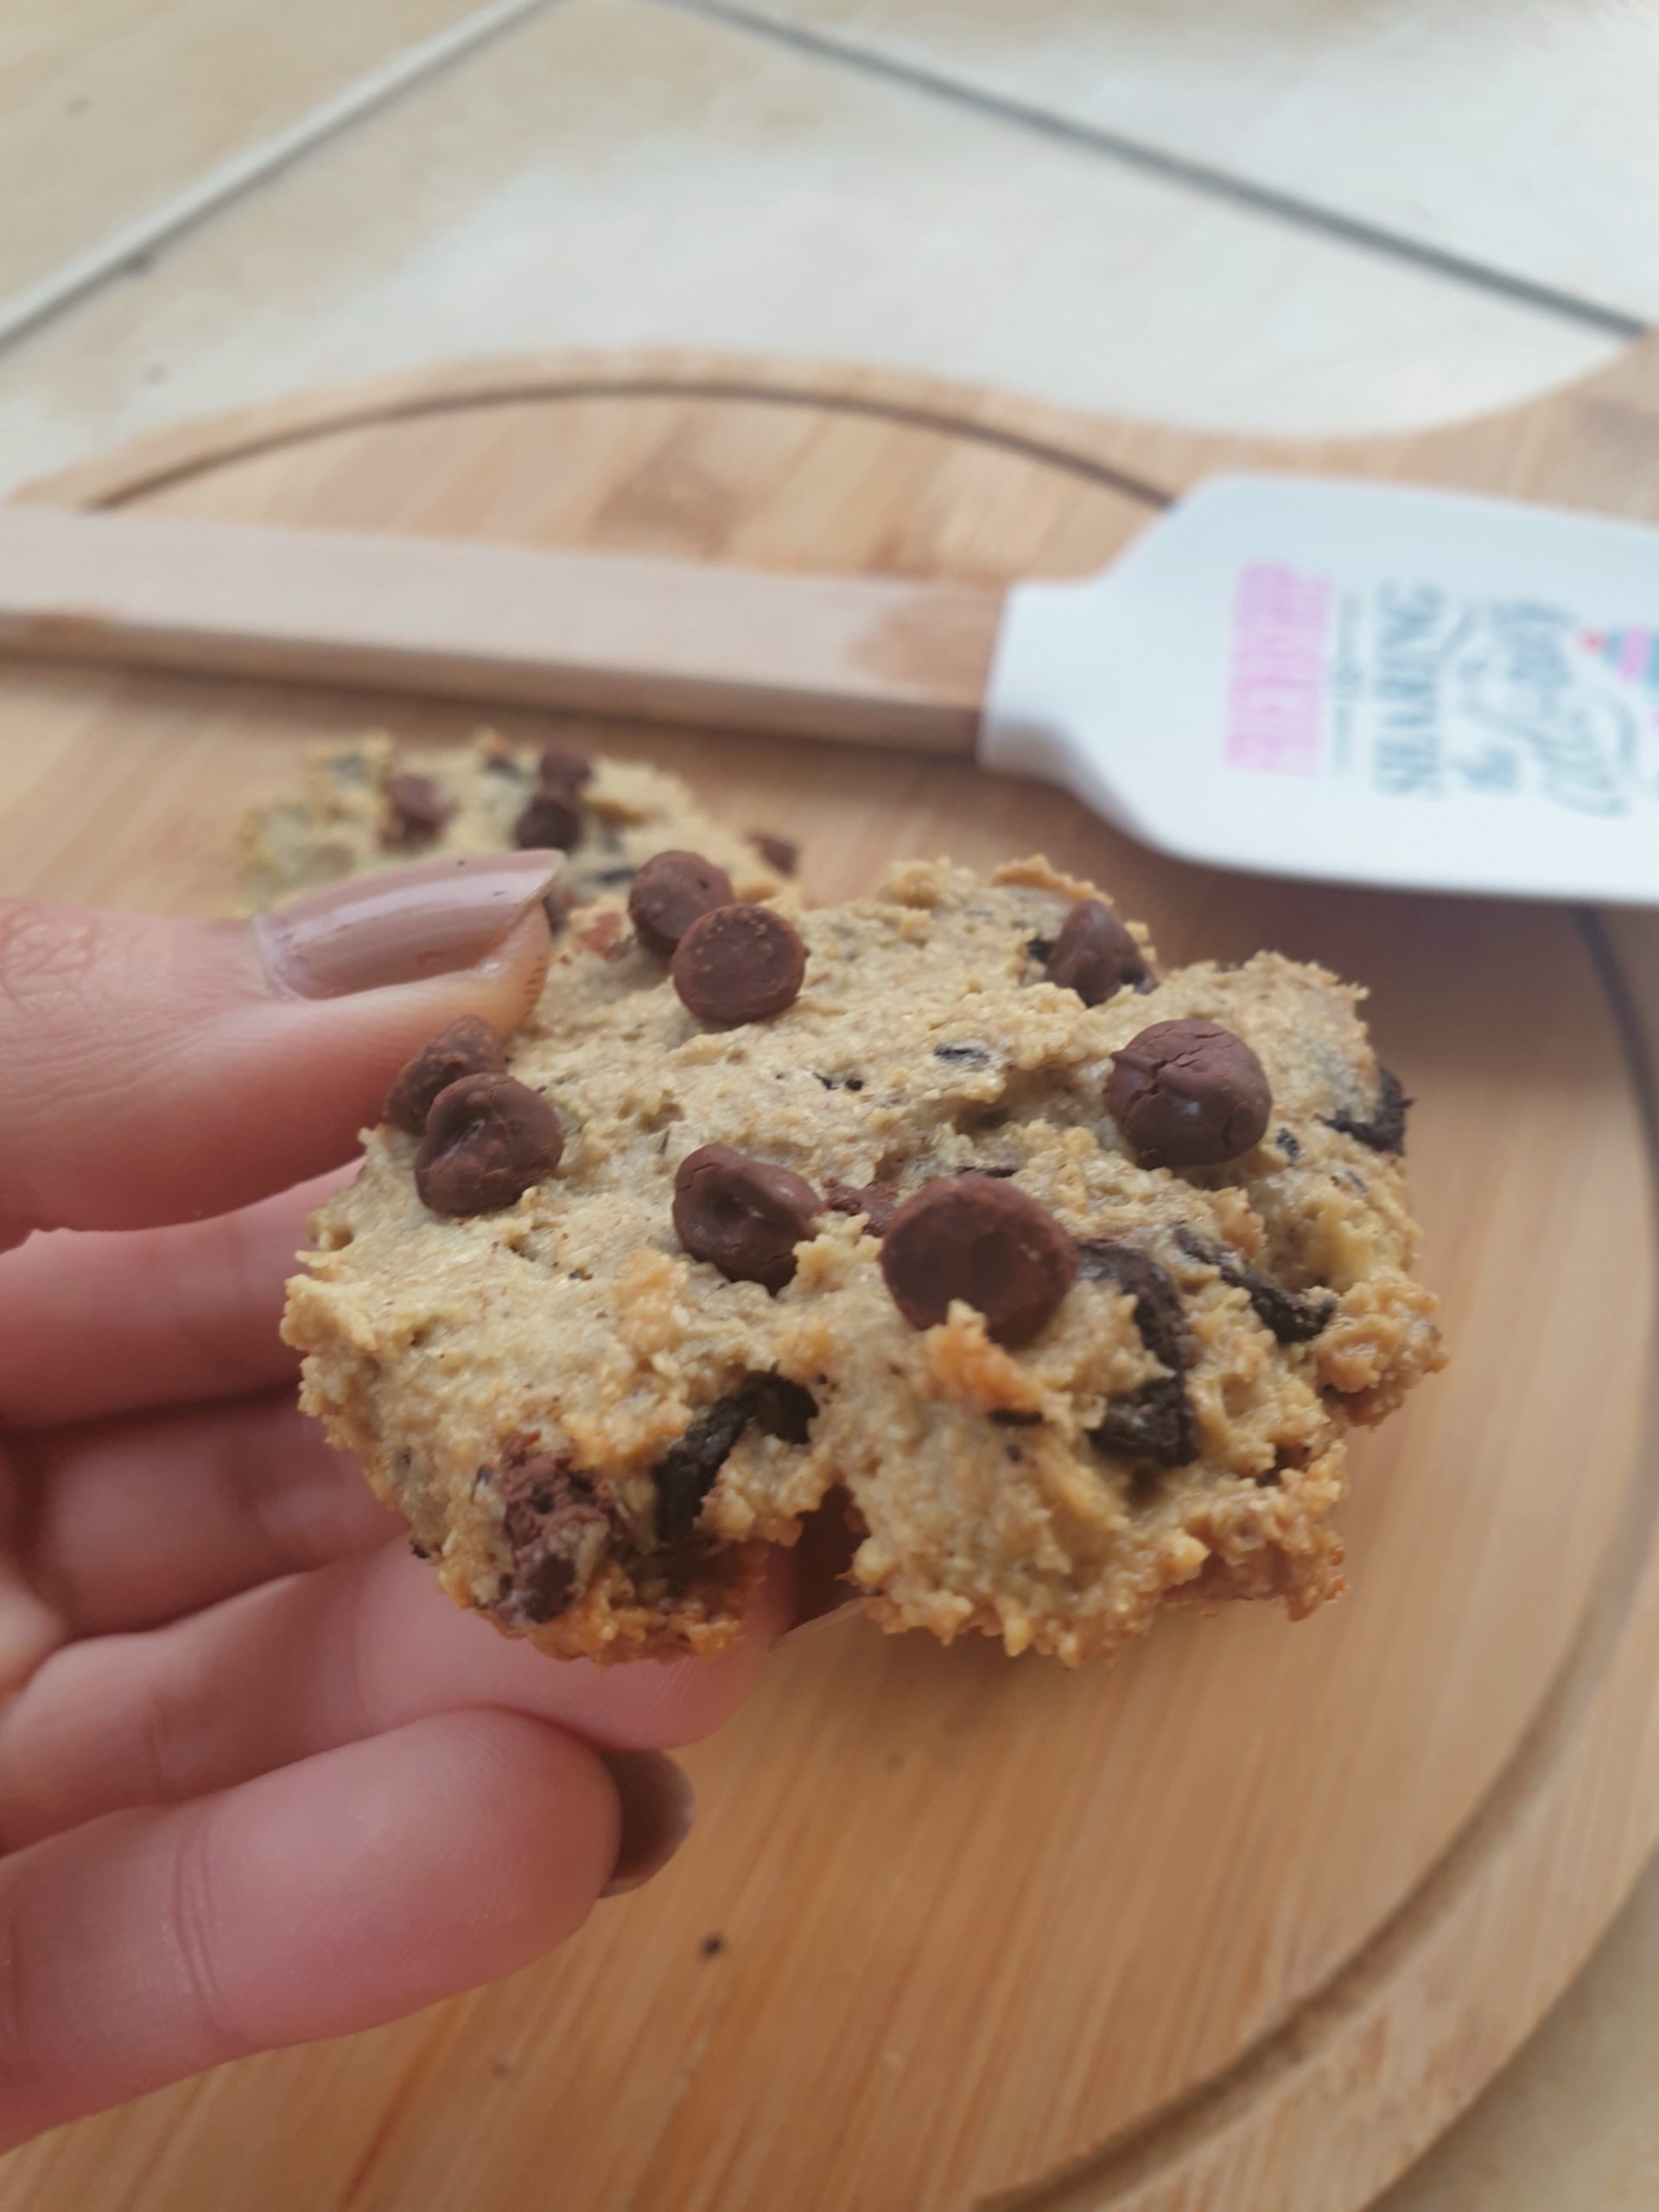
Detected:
left=0, top=0, right=557, bottom=347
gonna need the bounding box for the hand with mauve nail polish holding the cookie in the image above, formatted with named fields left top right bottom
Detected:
left=0, top=854, right=783, bottom=2148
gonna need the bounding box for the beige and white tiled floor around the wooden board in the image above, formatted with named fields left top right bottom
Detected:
left=0, top=0, right=1659, bottom=2212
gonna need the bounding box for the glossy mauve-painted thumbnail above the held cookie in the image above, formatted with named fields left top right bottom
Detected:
left=254, top=852, right=564, bottom=998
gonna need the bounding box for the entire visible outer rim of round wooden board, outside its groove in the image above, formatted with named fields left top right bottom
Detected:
left=29, top=353, right=1659, bottom=2212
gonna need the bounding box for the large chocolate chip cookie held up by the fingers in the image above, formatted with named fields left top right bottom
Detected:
left=285, top=852, right=1440, bottom=1663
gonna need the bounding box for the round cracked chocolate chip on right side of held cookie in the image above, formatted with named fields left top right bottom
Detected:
left=1106, top=1022, right=1272, bottom=1168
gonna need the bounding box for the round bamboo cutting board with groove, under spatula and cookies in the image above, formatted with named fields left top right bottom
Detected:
left=0, top=347, right=1659, bottom=2212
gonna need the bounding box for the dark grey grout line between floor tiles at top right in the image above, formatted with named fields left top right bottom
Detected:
left=646, top=0, right=1648, bottom=339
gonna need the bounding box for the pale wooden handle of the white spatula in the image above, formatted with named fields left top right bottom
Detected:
left=0, top=506, right=1002, bottom=754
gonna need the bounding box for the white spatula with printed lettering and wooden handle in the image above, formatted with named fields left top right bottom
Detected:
left=0, top=475, right=1659, bottom=905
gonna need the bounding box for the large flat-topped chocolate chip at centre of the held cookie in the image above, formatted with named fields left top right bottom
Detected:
left=880, top=1174, right=1077, bottom=1344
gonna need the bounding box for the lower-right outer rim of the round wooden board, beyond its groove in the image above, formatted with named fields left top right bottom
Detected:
left=995, top=912, right=1659, bottom=2212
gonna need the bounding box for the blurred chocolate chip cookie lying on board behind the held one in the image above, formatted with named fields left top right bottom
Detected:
left=241, top=730, right=797, bottom=927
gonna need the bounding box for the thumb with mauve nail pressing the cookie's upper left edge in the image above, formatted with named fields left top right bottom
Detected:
left=0, top=852, right=560, bottom=1249
